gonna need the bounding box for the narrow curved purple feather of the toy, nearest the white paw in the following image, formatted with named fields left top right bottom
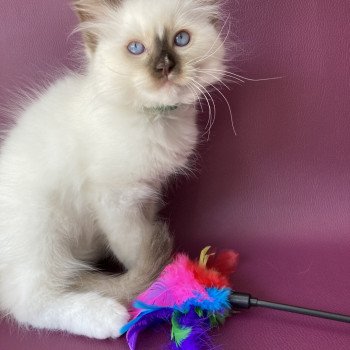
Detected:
left=126, top=308, right=174, bottom=350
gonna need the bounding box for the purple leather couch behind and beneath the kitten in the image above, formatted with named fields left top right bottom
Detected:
left=0, top=0, right=350, bottom=350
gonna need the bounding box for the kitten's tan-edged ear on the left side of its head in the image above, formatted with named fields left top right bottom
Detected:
left=72, top=0, right=123, bottom=54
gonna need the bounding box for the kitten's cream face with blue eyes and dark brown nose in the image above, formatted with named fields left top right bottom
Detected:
left=75, top=0, right=224, bottom=107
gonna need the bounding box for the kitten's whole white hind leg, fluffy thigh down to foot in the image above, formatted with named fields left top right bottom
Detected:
left=0, top=206, right=129, bottom=339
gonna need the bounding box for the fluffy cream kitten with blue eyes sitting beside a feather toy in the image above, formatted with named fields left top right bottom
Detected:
left=0, top=0, right=224, bottom=339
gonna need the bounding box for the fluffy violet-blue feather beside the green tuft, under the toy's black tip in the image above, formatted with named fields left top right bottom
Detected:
left=169, top=308, right=213, bottom=350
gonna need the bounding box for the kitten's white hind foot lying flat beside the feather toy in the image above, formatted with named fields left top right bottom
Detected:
left=4, top=274, right=129, bottom=339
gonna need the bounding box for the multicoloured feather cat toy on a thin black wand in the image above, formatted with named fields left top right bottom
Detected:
left=121, top=247, right=350, bottom=350
